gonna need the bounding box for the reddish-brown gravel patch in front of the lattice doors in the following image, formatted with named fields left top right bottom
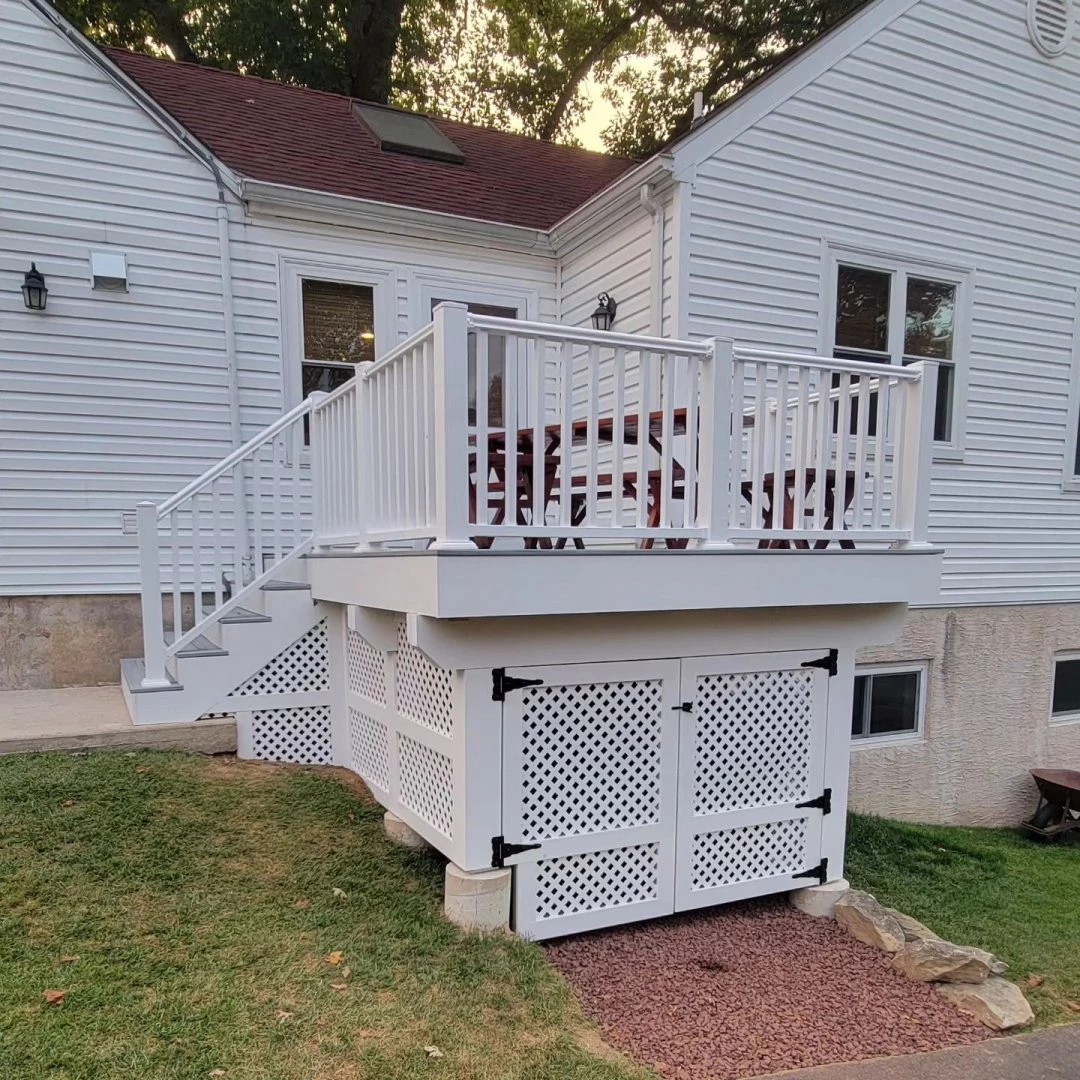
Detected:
left=548, top=900, right=990, bottom=1080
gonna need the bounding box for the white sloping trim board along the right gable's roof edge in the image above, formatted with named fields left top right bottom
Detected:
left=674, top=0, right=921, bottom=174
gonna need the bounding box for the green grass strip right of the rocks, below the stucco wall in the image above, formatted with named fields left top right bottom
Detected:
left=847, top=815, right=1080, bottom=1025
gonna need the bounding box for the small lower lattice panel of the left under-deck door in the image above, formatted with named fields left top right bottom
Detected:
left=536, top=843, right=660, bottom=921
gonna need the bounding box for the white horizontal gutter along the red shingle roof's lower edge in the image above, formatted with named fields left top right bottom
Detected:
left=240, top=177, right=551, bottom=254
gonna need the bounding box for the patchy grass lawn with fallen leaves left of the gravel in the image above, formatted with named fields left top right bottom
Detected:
left=0, top=753, right=647, bottom=1080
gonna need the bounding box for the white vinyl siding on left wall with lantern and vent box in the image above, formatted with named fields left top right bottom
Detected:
left=0, top=0, right=229, bottom=593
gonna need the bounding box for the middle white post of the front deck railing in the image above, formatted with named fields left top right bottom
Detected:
left=690, top=338, right=741, bottom=549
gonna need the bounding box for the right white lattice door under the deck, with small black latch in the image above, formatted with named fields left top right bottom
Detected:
left=675, top=650, right=829, bottom=910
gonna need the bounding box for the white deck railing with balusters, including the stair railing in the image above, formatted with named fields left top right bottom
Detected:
left=138, top=303, right=937, bottom=686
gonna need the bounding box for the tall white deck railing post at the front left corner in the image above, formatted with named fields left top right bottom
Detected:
left=431, top=302, right=475, bottom=551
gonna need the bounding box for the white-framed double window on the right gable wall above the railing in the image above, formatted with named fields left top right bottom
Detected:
left=828, top=253, right=966, bottom=445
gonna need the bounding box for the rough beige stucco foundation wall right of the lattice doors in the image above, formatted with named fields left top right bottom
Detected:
left=851, top=604, right=1080, bottom=825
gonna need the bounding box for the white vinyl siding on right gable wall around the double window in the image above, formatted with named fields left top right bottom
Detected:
left=686, top=0, right=1080, bottom=604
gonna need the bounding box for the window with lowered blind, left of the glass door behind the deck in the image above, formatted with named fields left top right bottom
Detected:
left=300, top=278, right=375, bottom=397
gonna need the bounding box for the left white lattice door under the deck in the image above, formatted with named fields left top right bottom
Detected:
left=499, top=661, right=680, bottom=939
